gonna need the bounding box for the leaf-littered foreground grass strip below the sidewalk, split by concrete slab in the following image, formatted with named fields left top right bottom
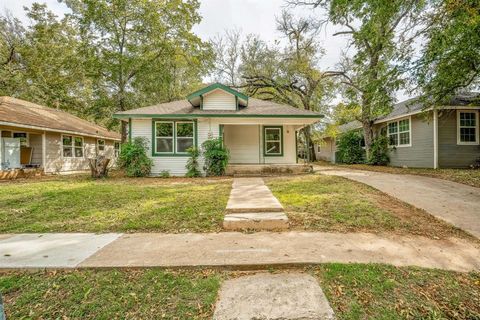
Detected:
left=0, top=264, right=480, bottom=319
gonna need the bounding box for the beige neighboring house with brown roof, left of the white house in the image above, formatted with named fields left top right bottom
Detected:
left=0, top=97, right=120, bottom=173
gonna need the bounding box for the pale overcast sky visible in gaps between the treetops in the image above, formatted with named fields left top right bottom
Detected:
left=0, top=0, right=408, bottom=100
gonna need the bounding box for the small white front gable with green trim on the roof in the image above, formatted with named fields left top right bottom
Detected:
left=187, top=83, right=248, bottom=111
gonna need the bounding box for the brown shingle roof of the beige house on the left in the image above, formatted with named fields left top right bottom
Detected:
left=0, top=97, right=120, bottom=140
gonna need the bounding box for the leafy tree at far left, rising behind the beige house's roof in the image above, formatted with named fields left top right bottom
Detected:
left=0, top=3, right=91, bottom=115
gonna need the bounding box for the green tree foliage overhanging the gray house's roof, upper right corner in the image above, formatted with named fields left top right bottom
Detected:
left=415, top=0, right=480, bottom=105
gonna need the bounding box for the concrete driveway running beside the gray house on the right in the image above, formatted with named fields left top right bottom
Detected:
left=314, top=166, right=480, bottom=238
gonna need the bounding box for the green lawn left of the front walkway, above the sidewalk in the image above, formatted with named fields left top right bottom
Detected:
left=0, top=176, right=231, bottom=233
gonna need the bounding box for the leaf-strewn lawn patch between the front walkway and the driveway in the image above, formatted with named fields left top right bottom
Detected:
left=266, top=175, right=470, bottom=238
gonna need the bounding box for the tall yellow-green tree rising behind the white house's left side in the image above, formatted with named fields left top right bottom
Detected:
left=62, top=0, right=212, bottom=140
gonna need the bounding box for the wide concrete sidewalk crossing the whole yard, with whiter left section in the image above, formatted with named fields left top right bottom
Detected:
left=0, top=232, right=480, bottom=271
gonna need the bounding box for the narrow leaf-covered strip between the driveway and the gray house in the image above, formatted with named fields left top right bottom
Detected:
left=315, top=161, right=480, bottom=188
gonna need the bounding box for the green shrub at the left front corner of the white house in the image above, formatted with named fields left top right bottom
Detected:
left=118, top=137, right=153, bottom=177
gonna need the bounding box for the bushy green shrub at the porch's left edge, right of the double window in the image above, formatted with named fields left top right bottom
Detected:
left=202, top=138, right=229, bottom=176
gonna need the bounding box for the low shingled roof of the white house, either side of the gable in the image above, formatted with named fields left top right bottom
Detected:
left=114, top=98, right=323, bottom=118
